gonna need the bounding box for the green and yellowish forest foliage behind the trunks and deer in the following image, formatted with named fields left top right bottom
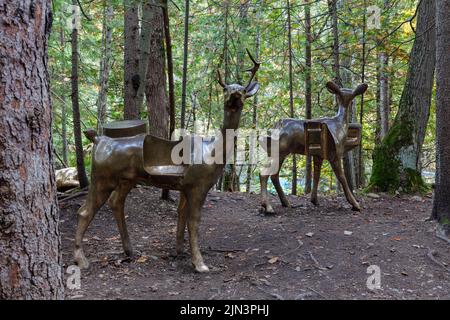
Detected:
left=49, top=0, right=434, bottom=190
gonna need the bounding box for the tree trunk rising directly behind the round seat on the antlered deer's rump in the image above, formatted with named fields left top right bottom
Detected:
left=123, top=0, right=141, bottom=119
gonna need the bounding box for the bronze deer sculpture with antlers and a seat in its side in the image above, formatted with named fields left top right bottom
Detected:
left=74, top=51, right=260, bottom=272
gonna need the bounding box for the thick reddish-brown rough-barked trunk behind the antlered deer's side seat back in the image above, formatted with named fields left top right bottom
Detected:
left=145, top=7, right=169, bottom=138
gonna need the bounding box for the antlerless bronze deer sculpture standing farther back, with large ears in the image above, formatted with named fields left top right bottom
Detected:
left=260, top=81, right=367, bottom=213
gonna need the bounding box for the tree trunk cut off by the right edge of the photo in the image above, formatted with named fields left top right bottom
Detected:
left=432, top=0, right=450, bottom=236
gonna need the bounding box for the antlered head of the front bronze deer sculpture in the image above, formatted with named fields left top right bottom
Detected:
left=217, top=49, right=260, bottom=124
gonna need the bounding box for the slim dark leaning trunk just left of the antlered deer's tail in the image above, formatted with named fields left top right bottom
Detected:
left=71, top=0, right=89, bottom=188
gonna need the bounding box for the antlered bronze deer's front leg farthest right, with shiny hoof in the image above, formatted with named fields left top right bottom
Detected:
left=186, top=189, right=209, bottom=272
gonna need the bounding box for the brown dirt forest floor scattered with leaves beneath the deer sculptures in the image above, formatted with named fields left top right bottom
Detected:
left=61, top=187, right=450, bottom=300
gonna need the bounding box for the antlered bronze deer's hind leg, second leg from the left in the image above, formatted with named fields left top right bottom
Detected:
left=108, top=181, right=134, bottom=256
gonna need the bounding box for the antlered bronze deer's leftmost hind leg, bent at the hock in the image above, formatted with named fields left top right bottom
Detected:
left=74, top=183, right=111, bottom=269
